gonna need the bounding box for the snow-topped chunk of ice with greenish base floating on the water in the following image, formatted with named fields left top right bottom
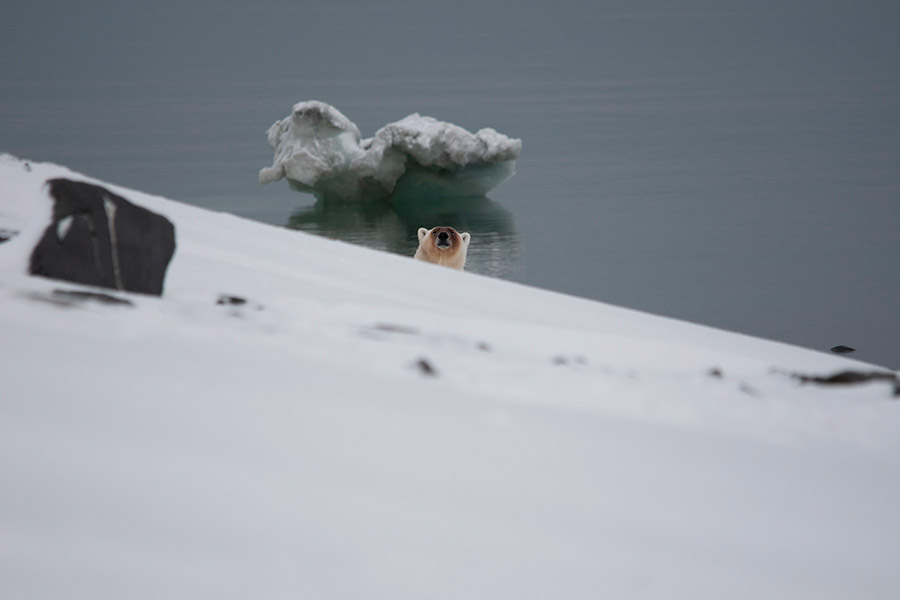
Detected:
left=259, top=100, right=522, bottom=198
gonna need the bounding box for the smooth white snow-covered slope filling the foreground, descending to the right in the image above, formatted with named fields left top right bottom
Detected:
left=0, top=155, right=900, bottom=600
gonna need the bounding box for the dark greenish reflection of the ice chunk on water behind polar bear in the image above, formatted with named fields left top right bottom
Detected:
left=287, top=188, right=520, bottom=279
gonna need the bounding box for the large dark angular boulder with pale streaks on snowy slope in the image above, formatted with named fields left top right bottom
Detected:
left=30, top=179, right=175, bottom=296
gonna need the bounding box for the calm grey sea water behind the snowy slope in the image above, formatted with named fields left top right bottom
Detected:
left=0, top=0, right=900, bottom=368
